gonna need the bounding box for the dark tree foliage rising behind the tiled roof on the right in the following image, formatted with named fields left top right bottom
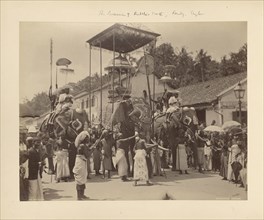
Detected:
left=152, top=43, right=247, bottom=88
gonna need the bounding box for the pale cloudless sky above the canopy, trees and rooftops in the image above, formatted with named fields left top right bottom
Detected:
left=19, top=22, right=247, bottom=102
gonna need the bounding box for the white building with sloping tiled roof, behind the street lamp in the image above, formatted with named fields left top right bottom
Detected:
left=175, top=72, right=247, bottom=126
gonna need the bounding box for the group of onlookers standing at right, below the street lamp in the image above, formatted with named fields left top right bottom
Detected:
left=189, top=124, right=247, bottom=192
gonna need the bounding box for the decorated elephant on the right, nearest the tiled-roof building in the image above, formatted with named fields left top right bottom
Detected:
left=154, top=107, right=198, bottom=171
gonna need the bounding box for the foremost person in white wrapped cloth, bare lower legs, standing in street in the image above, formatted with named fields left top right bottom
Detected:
left=73, top=144, right=88, bottom=200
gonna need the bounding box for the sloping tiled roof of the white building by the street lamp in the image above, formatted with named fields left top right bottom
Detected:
left=178, top=72, right=247, bottom=106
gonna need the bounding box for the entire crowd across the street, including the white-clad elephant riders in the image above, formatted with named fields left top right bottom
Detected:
left=19, top=89, right=247, bottom=201
